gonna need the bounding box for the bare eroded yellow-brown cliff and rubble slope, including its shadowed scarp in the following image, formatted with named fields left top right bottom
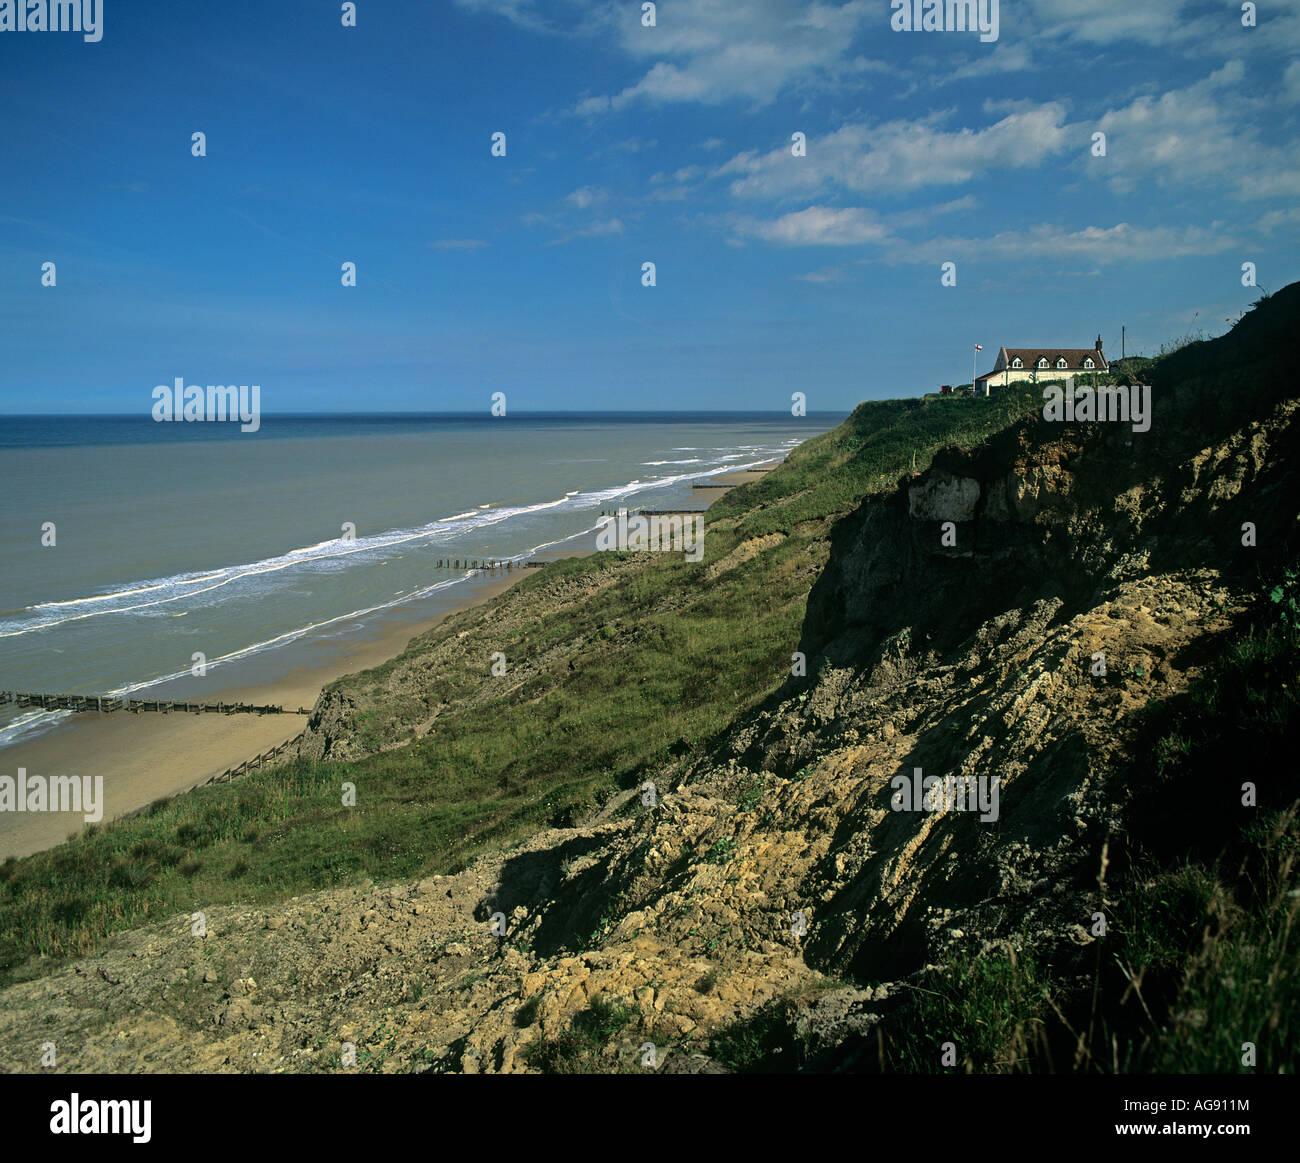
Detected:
left=0, top=288, right=1300, bottom=1071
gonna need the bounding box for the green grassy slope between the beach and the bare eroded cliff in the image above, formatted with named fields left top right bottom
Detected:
left=0, top=390, right=1040, bottom=980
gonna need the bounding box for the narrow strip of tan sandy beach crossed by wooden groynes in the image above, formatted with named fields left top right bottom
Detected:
left=0, top=461, right=776, bottom=859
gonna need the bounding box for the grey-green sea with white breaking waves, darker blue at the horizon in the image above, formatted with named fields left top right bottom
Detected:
left=0, top=412, right=844, bottom=746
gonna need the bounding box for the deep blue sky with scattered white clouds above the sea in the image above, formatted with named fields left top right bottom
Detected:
left=0, top=0, right=1300, bottom=413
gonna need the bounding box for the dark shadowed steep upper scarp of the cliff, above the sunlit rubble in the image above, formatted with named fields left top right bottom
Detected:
left=801, top=374, right=1295, bottom=680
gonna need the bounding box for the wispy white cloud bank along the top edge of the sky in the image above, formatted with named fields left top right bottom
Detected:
left=456, top=0, right=1300, bottom=117
